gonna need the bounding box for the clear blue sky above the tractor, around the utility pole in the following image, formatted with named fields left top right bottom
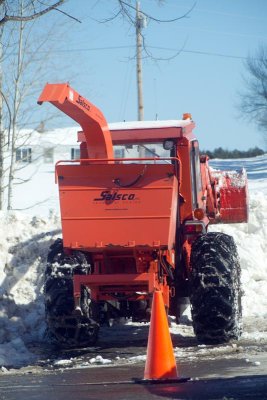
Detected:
left=39, top=0, right=267, bottom=150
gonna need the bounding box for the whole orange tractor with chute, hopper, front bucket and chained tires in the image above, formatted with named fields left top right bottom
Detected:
left=38, top=84, right=248, bottom=347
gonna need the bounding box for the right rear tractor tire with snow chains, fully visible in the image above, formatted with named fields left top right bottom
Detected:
left=190, top=232, right=242, bottom=344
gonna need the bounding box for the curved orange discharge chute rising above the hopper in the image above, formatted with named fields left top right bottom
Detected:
left=38, top=83, right=114, bottom=159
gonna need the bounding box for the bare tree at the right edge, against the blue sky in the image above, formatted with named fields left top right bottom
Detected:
left=239, top=46, right=267, bottom=145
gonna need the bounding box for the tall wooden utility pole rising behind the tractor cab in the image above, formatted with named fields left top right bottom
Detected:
left=136, top=1, right=146, bottom=121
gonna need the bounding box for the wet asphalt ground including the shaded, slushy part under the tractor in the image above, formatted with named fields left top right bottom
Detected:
left=0, top=321, right=267, bottom=400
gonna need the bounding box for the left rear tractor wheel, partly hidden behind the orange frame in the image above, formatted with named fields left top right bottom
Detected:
left=44, top=239, right=99, bottom=348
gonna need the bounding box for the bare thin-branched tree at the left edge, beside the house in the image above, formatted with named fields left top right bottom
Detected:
left=0, top=0, right=72, bottom=209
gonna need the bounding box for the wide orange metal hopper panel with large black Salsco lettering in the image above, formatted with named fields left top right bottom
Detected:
left=57, top=164, right=178, bottom=251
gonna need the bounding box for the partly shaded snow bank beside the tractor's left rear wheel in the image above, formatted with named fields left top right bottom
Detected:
left=0, top=212, right=61, bottom=366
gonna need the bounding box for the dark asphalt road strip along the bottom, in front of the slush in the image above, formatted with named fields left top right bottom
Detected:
left=0, top=360, right=267, bottom=400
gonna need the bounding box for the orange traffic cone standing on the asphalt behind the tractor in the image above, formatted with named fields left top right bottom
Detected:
left=144, top=290, right=178, bottom=380
